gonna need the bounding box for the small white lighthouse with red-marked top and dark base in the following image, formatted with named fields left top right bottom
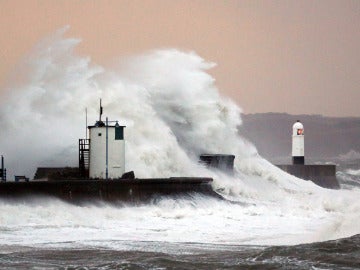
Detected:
left=292, top=120, right=305, bottom=165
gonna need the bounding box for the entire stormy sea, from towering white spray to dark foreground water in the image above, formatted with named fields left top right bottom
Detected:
left=0, top=29, right=360, bottom=269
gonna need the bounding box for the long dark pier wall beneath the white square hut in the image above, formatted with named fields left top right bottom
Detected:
left=0, top=177, right=220, bottom=203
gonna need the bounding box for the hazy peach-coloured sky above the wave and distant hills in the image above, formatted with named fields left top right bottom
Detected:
left=0, top=0, right=360, bottom=117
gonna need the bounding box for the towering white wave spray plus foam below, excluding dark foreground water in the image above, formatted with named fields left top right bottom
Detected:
left=0, top=29, right=360, bottom=246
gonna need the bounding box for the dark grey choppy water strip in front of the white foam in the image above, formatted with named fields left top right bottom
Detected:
left=0, top=235, right=360, bottom=269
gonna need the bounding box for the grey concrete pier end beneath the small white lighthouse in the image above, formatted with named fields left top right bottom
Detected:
left=276, top=164, right=340, bottom=189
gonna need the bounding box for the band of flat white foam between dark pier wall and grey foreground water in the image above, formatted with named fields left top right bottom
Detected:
left=0, top=168, right=359, bottom=251
